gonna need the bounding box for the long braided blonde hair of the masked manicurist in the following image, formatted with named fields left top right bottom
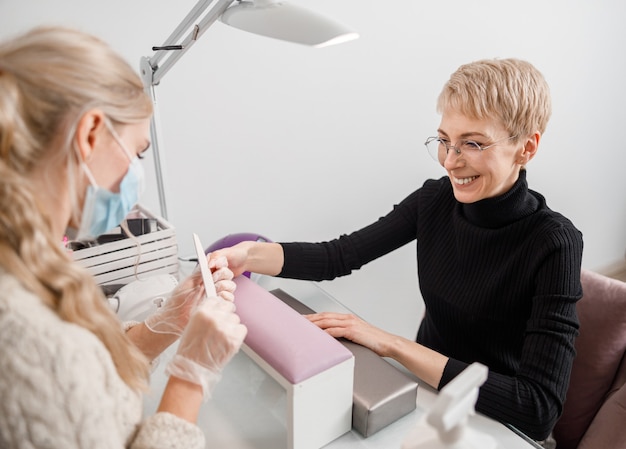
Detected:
left=0, top=27, right=152, bottom=390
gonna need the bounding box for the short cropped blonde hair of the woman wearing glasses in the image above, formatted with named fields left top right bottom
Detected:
left=437, top=59, right=552, bottom=136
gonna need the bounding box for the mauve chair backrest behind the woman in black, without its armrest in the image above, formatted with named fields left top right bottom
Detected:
left=554, top=270, right=626, bottom=449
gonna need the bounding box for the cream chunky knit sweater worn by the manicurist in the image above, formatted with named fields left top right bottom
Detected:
left=0, top=270, right=205, bottom=449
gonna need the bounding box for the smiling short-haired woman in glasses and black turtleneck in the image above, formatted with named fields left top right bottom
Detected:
left=214, top=59, right=583, bottom=440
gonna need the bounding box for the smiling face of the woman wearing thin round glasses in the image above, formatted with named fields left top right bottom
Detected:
left=438, top=109, right=540, bottom=203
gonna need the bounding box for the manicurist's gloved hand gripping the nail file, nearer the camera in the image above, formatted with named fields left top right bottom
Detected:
left=165, top=297, right=248, bottom=401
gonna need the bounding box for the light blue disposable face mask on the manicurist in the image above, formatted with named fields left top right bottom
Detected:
left=76, top=124, right=144, bottom=240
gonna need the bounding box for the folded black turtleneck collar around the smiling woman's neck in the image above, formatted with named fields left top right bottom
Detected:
left=461, top=170, right=539, bottom=228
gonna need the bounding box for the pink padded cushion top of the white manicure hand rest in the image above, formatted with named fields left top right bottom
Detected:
left=235, top=276, right=352, bottom=384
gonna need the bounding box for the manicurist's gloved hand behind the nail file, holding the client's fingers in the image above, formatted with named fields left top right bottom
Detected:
left=144, top=257, right=237, bottom=336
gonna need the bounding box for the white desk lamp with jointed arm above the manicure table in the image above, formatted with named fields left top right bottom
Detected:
left=140, top=0, right=358, bottom=219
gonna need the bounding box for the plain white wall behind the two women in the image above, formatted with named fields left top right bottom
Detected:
left=0, top=0, right=626, bottom=336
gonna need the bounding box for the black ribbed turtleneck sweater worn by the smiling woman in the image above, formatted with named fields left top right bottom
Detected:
left=279, top=171, right=583, bottom=439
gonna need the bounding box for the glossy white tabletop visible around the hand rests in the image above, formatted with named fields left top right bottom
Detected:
left=144, top=276, right=537, bottom=449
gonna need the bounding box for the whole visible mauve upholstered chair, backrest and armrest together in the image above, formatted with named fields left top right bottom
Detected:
left=553, top=269, right=626, bottom=449
